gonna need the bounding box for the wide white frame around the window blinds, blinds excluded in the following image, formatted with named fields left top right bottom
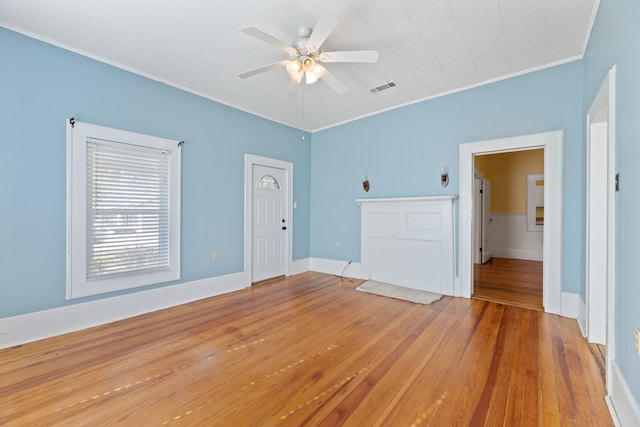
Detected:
left=66, top=119, right=182, bottom=300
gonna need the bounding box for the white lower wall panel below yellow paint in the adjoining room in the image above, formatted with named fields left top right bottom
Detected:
left=491, top=213, right=543, bottom=261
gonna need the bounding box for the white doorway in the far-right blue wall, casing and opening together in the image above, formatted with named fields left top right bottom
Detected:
left=585, top=66, right=616, bottom=392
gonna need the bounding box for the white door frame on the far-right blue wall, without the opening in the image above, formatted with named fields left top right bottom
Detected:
left=585, top=66, right=616, bottom=391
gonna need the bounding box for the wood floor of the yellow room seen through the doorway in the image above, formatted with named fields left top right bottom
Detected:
left=473, top=258, right=543, bottom=311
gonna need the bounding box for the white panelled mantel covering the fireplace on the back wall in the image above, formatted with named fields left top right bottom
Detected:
left=356, top=196, right=456, bottom=295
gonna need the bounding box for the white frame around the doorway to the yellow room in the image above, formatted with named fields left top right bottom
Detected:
left=456, top=130, right=564, bottom=314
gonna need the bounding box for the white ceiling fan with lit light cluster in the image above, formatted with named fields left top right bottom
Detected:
left=239, top=15, right=378, bottom=100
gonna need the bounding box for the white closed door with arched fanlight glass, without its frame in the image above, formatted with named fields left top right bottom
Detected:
left=251, top=164, right=288, bottom=282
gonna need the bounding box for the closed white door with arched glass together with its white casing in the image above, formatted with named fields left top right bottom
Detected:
left=244, top=154, right=293, bottom=287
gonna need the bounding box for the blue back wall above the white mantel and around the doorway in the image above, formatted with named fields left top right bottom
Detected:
left=311, top=61, right=585, bottom=293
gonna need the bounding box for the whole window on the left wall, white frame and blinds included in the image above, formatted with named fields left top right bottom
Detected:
left=67, top=121, right=181, bottom=299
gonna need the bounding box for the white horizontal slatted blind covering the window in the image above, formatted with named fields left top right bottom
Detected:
left=86, top=138, right=170, bottom=280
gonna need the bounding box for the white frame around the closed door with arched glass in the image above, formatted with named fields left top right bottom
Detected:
left=244, top=153, right=294, bottom=288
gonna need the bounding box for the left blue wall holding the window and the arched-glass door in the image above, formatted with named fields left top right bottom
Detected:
left=0, top=28, right=310, bottom=318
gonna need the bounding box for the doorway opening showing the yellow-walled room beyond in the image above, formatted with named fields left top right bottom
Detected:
left=472, top=148, right=544, bottom=311
